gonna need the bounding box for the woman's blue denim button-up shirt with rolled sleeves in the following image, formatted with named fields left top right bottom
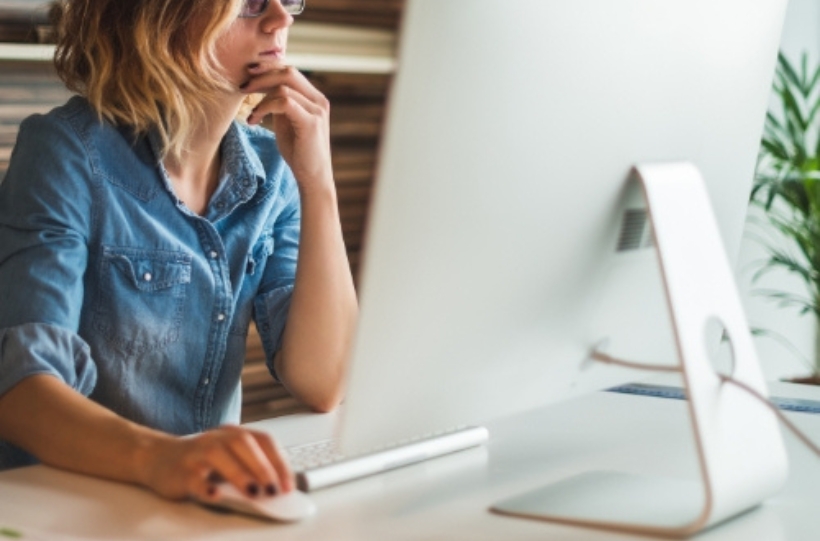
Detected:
left=0, top=97, right=300, bottom=469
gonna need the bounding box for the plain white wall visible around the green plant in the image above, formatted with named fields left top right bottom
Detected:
left=739, top=0, right=820, bottom=380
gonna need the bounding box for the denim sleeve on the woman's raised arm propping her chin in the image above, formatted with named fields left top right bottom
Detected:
left=254, top=170, right=301, bottom=381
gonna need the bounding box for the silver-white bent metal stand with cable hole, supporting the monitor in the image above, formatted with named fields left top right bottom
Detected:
left=492, top=163, right=788, bottom=537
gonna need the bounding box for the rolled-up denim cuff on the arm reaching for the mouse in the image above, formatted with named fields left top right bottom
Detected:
left=0, top=323, right=97, bottom=396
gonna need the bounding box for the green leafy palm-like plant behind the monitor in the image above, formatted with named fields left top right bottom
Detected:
left=751, top=48, right=820, bottom=383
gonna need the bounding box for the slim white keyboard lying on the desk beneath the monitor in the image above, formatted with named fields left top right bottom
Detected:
left=286, top=426, right=489, bottom=492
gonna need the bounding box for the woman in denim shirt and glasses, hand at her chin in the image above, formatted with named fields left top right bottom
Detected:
left=0, top=0, right=357, bottom=499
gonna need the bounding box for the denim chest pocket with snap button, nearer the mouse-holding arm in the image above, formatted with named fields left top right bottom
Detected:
left=94, top=247, right=191, bottom=356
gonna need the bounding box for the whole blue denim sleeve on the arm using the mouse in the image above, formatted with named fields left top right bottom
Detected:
left=0, top=112, right=96, bottom=395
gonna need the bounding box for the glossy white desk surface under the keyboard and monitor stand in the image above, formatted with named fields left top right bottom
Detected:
left=0, top=384, right=820, bottom=541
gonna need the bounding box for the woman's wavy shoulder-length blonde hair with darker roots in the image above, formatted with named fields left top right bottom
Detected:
left=52, top=0, right=242, bottom=158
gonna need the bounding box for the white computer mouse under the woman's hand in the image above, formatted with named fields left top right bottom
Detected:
left=202, top=483, right=316, bottom=522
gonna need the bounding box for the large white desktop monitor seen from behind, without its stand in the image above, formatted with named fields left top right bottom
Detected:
left=334, top=0, right=786, bottom=532
